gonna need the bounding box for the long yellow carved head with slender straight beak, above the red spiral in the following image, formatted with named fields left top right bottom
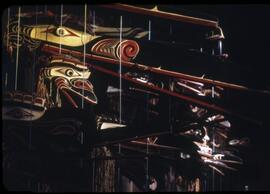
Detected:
left=4, top=20, right=148, bottom=50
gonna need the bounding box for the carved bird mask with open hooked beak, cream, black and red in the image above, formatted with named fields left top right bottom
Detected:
left=37, top=58, right=97, bottom=108
